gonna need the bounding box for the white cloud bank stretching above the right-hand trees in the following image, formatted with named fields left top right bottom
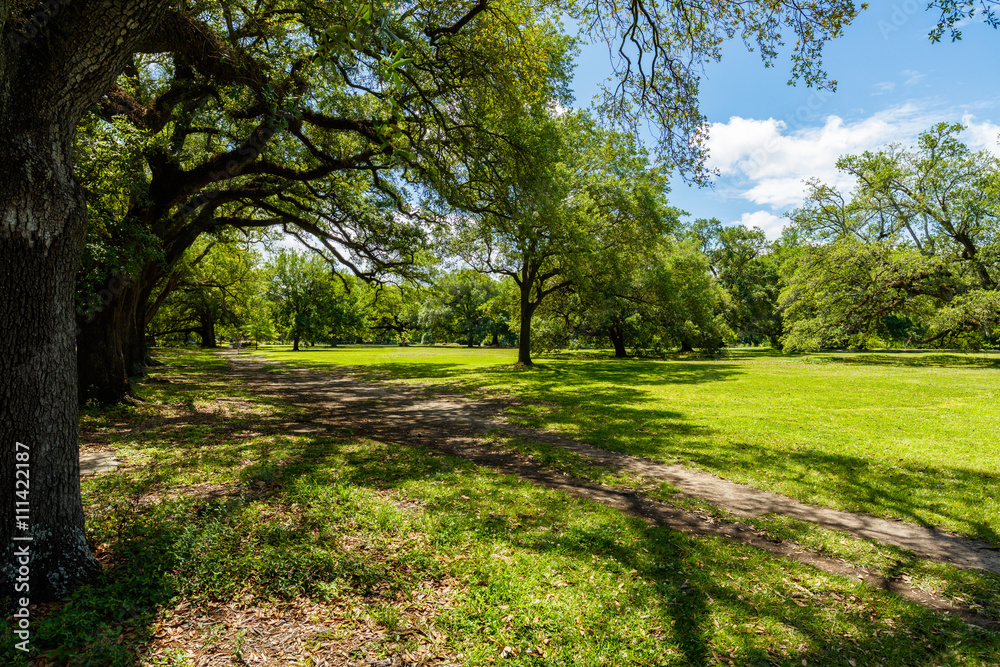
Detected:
left=708, top=104, right=1000, bottom=212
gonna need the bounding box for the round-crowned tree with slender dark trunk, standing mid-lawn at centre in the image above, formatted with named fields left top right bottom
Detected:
left=451, top=109, right=675, bottom=366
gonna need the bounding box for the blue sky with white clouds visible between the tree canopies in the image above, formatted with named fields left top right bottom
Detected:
left=574, top=0, right=1000, bottom=238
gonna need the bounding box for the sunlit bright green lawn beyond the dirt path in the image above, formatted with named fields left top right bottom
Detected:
left=252, top=346, right=1000, bottom=545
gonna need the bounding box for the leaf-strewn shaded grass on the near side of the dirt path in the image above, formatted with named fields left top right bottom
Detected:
left=0, top=352, right=1000, bottom=666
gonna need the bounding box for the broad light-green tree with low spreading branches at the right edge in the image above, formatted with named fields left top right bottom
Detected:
left=782, top=124, right=1000, bottom=348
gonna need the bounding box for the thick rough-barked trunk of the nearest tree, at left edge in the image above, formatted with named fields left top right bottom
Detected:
left=0, top=0, right=172, bottom=603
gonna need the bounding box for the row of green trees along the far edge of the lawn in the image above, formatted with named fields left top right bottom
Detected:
left=150, top=125, right=1000, bottom=365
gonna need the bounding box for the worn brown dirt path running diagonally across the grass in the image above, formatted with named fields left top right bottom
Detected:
left=222, top=351, right=1000, bottom=630
